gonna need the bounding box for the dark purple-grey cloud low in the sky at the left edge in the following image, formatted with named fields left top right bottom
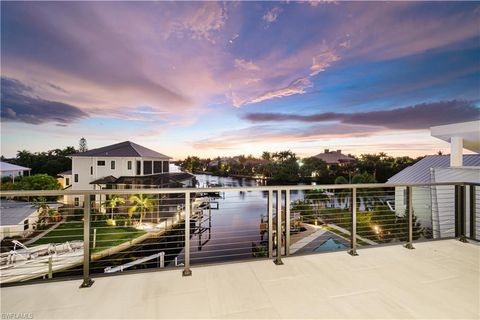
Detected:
left=1, top=77, right=88, bottom=126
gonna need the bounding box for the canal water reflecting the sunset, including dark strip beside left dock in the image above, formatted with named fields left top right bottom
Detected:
left=91, top=174, right=304, bottom=272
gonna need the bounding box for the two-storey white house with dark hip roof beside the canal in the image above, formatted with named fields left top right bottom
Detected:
left=59, top=141, right=194, bottom=206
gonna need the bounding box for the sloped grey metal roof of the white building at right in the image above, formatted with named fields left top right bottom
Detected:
left=387, top=154, right=480, bottom=183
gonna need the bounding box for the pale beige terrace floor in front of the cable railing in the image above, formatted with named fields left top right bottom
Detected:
left=1, top=240, right=480, bottom=319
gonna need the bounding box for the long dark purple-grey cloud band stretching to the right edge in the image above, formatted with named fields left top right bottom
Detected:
left=244, top=100, right=480, bottom=130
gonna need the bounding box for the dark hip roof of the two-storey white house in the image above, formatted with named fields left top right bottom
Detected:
left=71, top=141, right=171, bottom=160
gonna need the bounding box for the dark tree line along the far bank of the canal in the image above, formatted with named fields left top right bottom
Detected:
left=179, top=150, right=422, bottom=184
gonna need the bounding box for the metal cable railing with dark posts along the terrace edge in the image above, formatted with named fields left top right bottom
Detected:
left=0, top=183, right=480, bottom=287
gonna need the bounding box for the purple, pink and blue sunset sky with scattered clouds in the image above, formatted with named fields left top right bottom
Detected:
left=0, top=1, right=480, bottom=159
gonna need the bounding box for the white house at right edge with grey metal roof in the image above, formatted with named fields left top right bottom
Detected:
left=387, top=121, right=480, bottom=238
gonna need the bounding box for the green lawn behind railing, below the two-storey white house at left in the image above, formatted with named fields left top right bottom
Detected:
left=33, top=221, right=145, bottom=252
